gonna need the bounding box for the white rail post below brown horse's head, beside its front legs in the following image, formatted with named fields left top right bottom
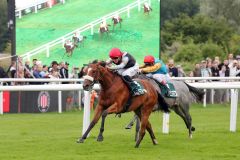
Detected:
left=82, top=91, right=90, bottom=135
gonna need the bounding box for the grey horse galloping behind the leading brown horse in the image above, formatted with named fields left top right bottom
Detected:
left=127, top=75, right=205, bottom=138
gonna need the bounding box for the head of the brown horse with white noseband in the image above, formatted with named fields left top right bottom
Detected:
left=83, top=61, right=106, bottom=91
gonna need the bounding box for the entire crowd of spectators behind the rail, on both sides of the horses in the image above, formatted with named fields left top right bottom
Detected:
left=0, top=53, right=240, bottom=82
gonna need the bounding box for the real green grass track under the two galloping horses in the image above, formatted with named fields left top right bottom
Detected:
left=0, top=105, right=240, bottom=160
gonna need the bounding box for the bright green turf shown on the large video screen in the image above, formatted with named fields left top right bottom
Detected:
left=17, top=0, right=160, bottom=66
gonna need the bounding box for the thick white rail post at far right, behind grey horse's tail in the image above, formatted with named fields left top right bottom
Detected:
left=230, top=89, right=238, bottom=132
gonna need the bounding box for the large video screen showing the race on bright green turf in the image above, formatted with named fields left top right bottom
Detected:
left=16, top=0, right=160, bottom=68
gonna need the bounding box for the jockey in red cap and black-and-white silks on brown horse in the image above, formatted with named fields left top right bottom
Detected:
left=107, top=48, right=144, bottom=96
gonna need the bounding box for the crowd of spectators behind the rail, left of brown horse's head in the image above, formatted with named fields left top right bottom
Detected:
left=0, top=58, right=84, bottom=84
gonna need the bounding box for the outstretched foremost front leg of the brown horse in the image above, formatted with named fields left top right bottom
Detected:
left=77, top=105, right=103, bottom=143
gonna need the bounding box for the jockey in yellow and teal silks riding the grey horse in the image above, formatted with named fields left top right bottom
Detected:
left=140, top=55, right=171, bottom=94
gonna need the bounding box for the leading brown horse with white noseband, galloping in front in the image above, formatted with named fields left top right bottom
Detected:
left=77, top=62, right=169, bottom=147
